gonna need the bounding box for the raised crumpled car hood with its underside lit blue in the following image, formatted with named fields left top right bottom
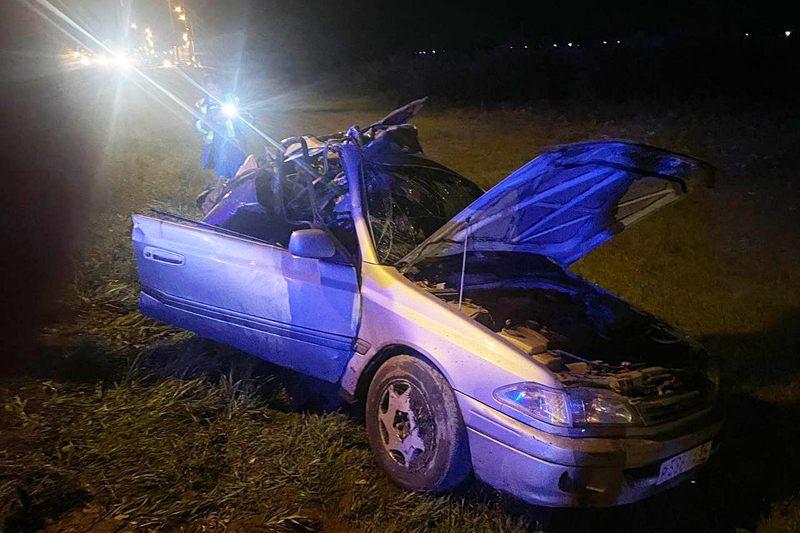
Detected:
left=400, top=141, right=713, bottom=267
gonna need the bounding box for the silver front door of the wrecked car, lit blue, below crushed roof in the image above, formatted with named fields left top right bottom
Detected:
left=132, top=215, right=360, bottom=382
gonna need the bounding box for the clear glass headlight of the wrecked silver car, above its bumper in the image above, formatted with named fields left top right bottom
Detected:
left=494, top=383, right=640, bottom=427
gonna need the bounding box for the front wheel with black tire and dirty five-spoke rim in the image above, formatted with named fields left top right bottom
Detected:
left=365, top=355, right=472, bottom=494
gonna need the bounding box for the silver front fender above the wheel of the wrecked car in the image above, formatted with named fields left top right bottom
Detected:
left=341, top=262, right=561, bottom=407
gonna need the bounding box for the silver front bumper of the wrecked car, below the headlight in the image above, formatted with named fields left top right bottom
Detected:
left=456, top=393, right=722, bottom=507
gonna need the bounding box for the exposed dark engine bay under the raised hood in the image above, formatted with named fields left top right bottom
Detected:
left=406, top=253, right=715, bottom=424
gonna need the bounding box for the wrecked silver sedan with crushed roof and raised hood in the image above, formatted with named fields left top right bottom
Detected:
left=132, top=101, right=722, bottom=506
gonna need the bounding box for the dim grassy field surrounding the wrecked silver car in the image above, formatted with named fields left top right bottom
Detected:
left=0, top=71, right=800, bottom=532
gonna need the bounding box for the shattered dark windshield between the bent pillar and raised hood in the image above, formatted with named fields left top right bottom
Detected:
left=365, top=160, right=483, bottom=265
